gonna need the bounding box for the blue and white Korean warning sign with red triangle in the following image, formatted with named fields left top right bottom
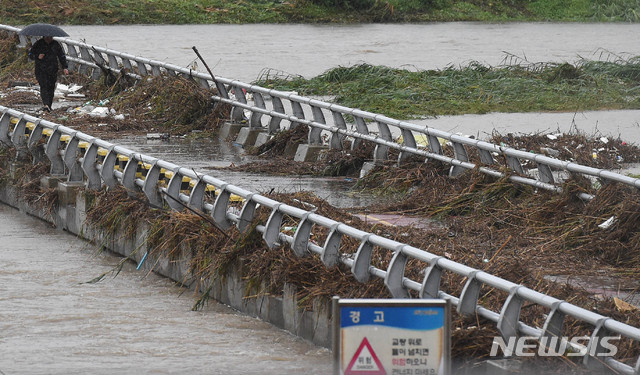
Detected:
left=333, top=297, right=451, bottom=375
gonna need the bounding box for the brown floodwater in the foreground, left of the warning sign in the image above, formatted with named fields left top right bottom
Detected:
left=0, top=204, right=331, bottom=375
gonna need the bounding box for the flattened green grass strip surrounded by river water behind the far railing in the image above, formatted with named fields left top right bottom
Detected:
left=256, top=57, right=640, bottom=119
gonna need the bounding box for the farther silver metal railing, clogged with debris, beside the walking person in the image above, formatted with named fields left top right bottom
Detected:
left=0, top=25, right=640, bottom=199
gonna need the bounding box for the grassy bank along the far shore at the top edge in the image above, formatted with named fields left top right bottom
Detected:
left=0, top=0, right=640, bottom=25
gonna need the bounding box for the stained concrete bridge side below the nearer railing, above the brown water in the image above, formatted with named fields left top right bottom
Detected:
left=0, top=176, right=332, bottom=348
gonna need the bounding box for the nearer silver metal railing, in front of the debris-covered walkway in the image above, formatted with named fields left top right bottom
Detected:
left=0, top=106, right=640, bottom=374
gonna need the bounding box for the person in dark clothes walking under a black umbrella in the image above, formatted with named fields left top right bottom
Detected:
left=29, top=36, right=69, bottom=112
